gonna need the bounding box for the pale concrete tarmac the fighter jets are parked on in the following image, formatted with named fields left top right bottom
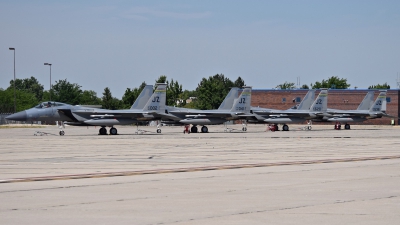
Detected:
left=0, top=124, right=400, bottom=224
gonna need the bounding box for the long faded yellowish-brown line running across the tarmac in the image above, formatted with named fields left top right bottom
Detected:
left=0, top=155, right=400, bottom=184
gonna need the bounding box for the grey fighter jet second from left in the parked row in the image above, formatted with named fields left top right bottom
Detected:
left=160, top=86, right=251, bottom=133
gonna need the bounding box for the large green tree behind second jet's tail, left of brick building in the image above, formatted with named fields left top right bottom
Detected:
left=194, top=74, right=244, bottom=109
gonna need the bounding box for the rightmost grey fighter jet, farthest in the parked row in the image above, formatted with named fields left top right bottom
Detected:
left=325, top=90, right=391, bottom=130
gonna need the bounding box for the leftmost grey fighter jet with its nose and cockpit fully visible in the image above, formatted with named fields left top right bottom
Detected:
left=6, top=84, right=166, bottom=135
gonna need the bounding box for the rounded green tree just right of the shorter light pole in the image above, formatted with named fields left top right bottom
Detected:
left=51, top=79, right=82, bottom=105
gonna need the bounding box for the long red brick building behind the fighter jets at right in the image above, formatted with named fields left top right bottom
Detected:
left=251, top=89, right=400, bottom=125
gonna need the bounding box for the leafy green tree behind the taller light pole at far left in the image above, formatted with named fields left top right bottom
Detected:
left=7, top=77, right=44, bottom=101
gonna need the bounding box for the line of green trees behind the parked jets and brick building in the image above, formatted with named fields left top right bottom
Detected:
left=0, top=74, right=390, bottom=113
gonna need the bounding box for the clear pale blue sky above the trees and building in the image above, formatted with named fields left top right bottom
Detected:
left=0, top=0, right=400, bottom=98
